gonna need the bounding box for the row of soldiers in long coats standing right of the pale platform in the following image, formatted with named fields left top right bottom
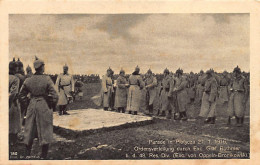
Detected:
left=101, top=66, right=249, bottom=126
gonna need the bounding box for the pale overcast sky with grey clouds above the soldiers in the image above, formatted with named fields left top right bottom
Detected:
left=9, top=14, right=250, bottom=75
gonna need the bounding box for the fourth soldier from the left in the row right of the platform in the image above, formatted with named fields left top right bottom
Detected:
left=145, top=69, right=157, bottom=115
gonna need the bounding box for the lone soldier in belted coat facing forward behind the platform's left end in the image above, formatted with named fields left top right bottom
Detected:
left=55, top=64, right=74, bottom=115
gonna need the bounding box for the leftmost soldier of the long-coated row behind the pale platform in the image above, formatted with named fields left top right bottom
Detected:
left=101, top=68, right=113, bottom=111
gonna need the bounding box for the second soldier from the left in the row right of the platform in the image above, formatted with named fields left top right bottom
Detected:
left=115, top=69, right=129, bottom=113
